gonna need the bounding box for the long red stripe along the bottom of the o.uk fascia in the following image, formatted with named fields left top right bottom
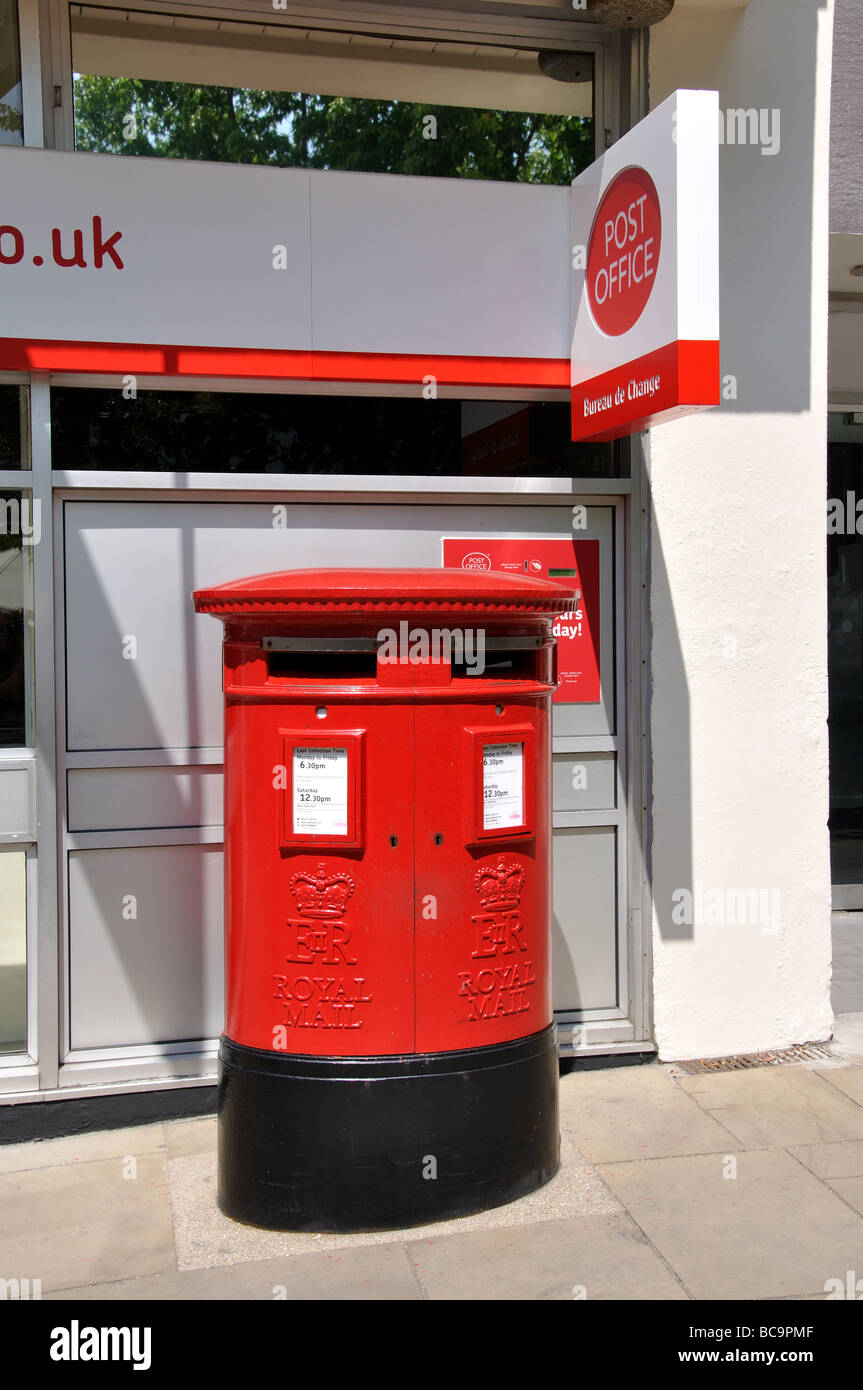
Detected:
left=0, top=338, right=570, bottom=391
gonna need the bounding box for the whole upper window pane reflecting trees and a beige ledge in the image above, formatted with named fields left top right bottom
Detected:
left=72, top=6, right=595, bottom=185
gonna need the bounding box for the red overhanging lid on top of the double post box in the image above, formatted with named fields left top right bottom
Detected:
left=193, top=569, right=578, bottom=617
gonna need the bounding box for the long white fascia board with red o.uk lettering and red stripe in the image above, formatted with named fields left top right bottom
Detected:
left=0, top=149, right=570, bottom=375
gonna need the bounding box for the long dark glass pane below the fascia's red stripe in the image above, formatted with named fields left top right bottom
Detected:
left=51, top=388, right=617, bottom=477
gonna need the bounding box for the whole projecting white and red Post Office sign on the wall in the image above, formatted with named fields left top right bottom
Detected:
left=571, top=90, right=720, bottom=441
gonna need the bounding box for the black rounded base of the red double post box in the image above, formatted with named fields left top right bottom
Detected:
left=218, top=1024, right=560, bottom=1232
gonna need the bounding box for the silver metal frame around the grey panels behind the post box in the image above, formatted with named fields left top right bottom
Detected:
left=51, top=458, right=644, bottom=1094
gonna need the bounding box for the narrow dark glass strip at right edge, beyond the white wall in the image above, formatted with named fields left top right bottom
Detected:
left=827, top=416, right=863, bottom=884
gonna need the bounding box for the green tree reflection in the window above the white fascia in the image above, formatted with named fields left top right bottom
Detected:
left=75, top=75, right=595, bottom=185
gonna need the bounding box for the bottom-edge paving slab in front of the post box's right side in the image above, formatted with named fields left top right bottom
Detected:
left=407, top=1215, right=687, bottom=1302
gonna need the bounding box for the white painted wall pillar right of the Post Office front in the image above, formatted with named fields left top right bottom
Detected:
left=649, top=0, right=832, bottom=1059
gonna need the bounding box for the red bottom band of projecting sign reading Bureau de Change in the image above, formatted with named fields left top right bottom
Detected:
left=573, top=339, right=720, bottom=441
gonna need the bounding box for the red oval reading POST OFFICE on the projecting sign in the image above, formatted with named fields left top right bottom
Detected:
left=586, top=165, right=661, bottom=338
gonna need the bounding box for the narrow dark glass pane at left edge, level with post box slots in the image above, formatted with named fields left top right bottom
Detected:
left=0, top=492, right=34, bottom=748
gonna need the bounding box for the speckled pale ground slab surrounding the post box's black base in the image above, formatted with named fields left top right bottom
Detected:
left=168, top=1137, right=621, bottom=1269
